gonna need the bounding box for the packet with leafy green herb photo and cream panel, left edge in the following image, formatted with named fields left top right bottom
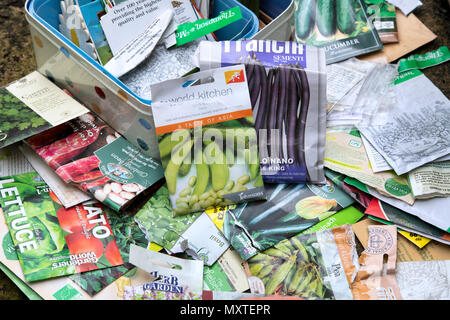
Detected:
left=0, top=71, right=89, bottom=148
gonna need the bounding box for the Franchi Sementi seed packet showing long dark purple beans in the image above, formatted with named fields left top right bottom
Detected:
left=196, top=40, right=327, bottom=183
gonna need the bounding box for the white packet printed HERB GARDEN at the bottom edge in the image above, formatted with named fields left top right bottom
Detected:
left=124, top=245, right=203, bottom=300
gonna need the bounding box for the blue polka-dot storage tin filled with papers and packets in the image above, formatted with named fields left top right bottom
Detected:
left=25, top=0, right=258, bottom=159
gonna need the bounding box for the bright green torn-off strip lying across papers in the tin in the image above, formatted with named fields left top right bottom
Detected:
left=176, top=7, right=242, bottom=46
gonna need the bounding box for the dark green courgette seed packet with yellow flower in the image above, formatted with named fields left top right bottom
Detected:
left=223, top=181, right=354, bottom=260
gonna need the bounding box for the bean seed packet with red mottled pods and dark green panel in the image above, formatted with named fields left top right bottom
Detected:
left=26, top=113, right=164, bottom=211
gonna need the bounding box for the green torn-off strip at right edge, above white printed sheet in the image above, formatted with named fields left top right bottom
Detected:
left=398, top=46, right=450, bottom=72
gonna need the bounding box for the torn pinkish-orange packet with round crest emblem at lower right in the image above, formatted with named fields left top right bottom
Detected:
left=352, top=226, right=402, bottom=300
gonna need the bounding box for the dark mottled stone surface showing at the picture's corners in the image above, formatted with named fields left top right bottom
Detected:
left=0, top=0, right=450, bottom=300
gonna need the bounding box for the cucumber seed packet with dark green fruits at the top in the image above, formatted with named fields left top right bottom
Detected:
left=294, top=0, right=383, bottom=64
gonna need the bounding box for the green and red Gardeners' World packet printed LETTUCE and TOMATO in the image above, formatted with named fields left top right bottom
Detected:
left=0, top=172, right=123, bottom=282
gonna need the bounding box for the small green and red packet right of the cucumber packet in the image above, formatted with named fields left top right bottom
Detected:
left=364, top=0, right=398, bottom=43
